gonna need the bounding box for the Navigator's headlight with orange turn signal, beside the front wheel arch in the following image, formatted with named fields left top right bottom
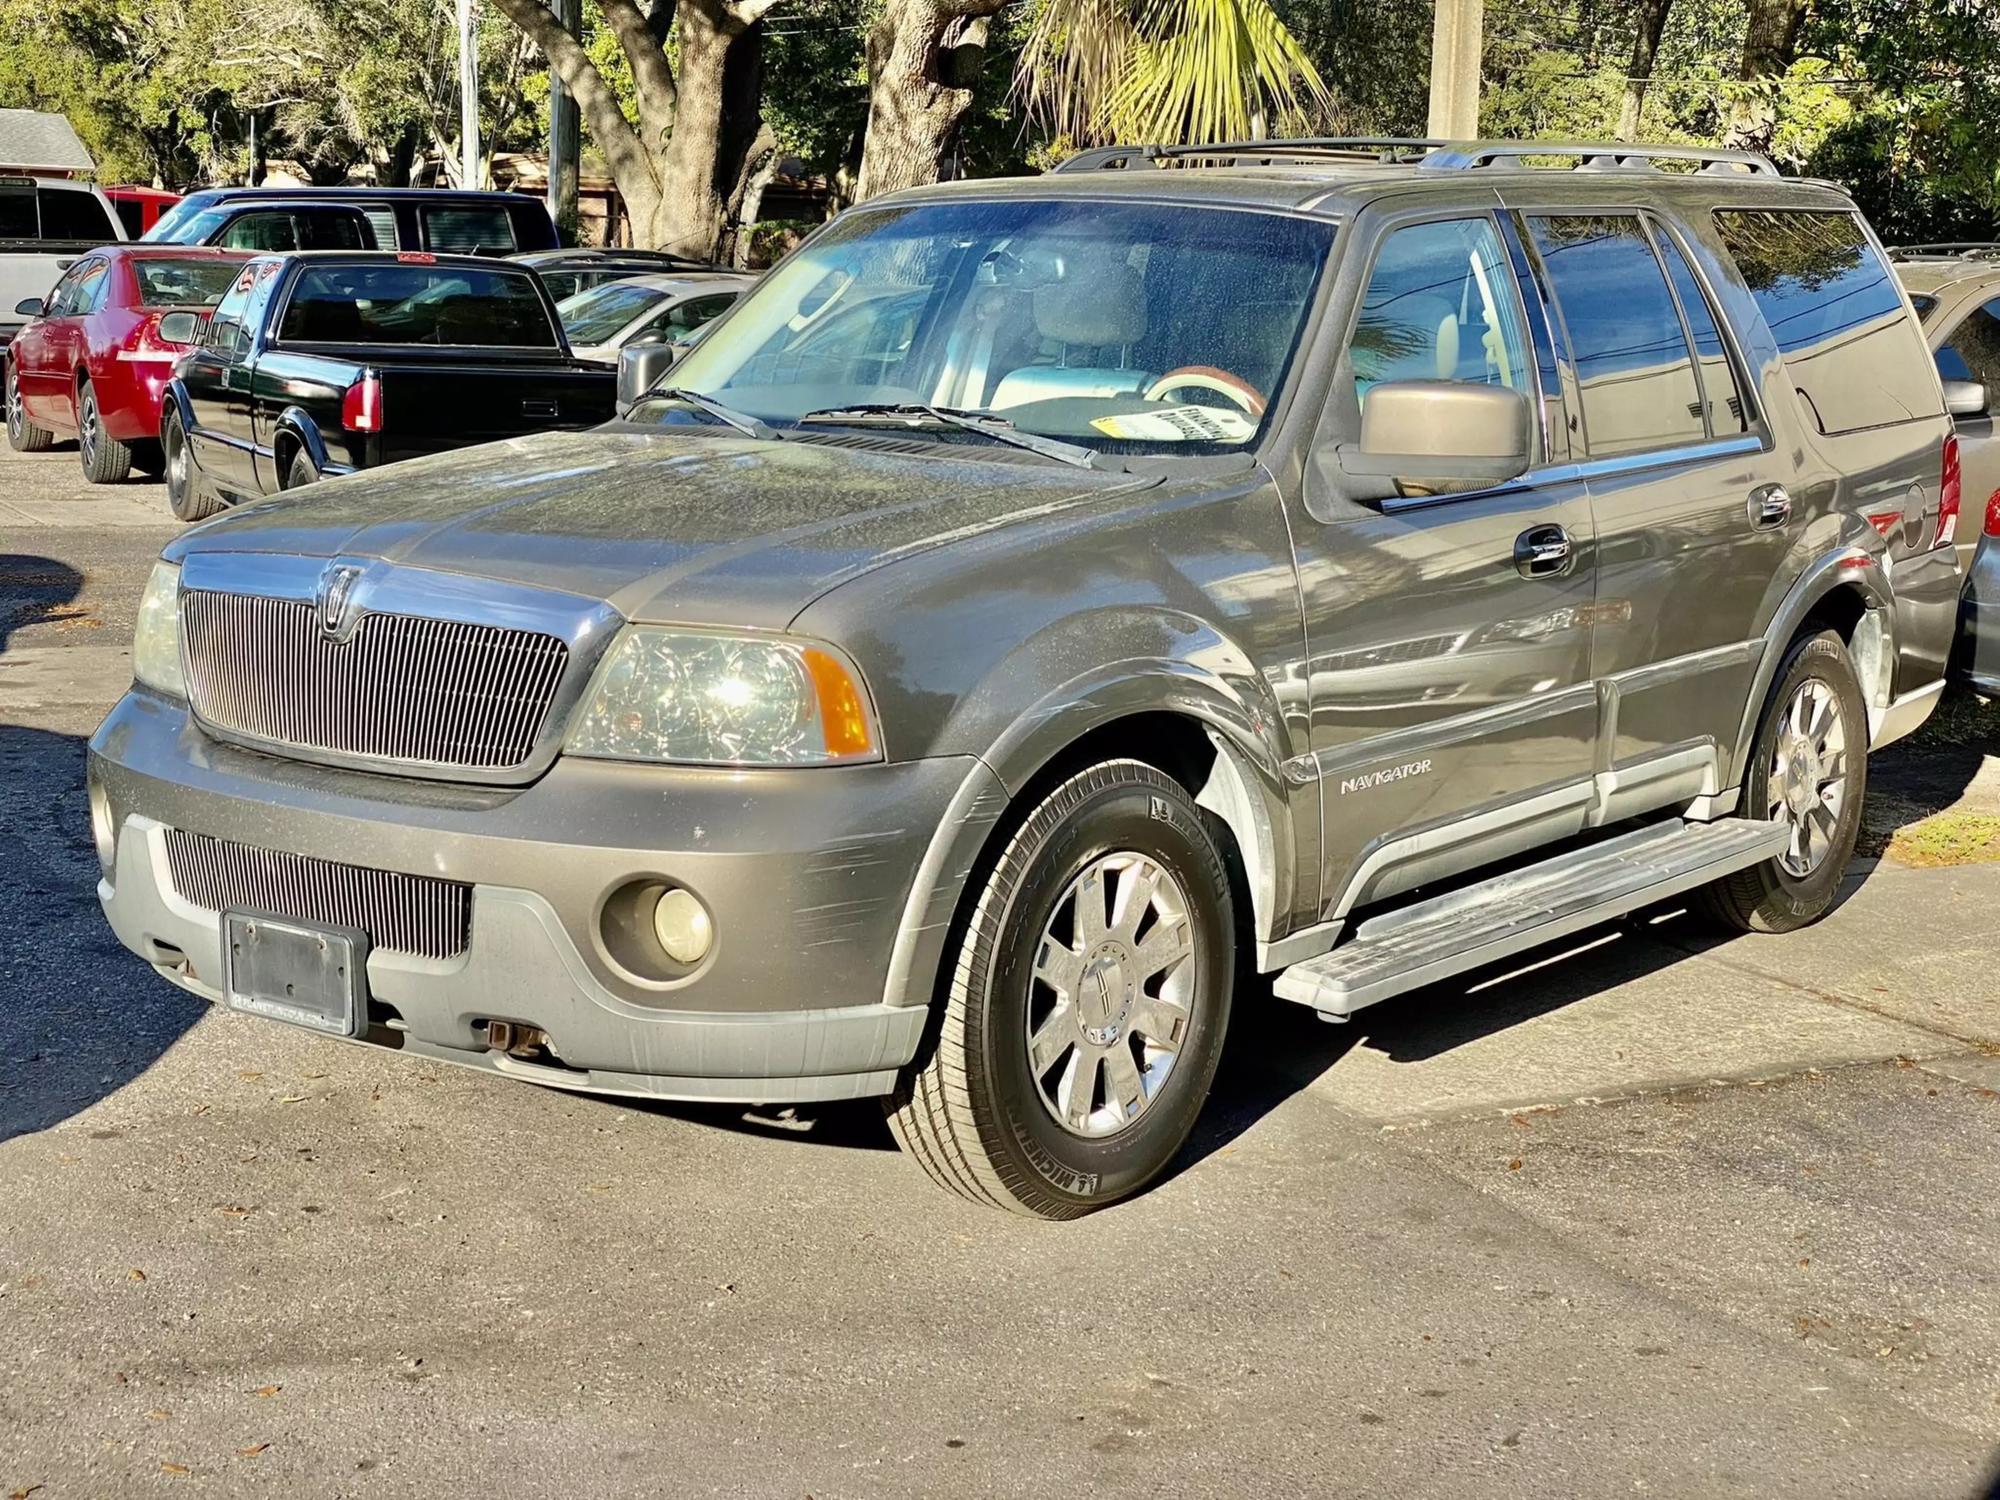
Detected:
left=564, top=626, right=882, bottom=766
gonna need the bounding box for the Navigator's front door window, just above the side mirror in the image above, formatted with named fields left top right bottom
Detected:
left=1352, top=218, right=1528, bottom=396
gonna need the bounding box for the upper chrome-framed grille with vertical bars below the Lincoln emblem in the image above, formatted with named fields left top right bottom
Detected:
left=180, top=588, right=570, bottom=770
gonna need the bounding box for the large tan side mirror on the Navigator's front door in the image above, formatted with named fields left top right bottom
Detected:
left=1338, top=380, right=1530, bottom=488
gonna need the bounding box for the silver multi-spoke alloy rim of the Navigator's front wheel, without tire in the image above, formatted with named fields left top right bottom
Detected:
left=1024, top=852, right=1198, bottom=1140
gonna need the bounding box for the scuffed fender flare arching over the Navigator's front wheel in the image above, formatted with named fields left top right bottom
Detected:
left=882, top=658, right=1296, bottom=1006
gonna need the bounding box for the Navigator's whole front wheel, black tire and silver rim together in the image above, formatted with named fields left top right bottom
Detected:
left=890, top=760, right=1236, bottom=1218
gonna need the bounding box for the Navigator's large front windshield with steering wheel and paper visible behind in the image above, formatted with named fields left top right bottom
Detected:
left=664, top=200, right=1334, bottom=452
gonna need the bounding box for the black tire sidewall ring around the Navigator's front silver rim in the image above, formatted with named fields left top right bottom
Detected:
left=968, top=772, right=1236, bottom=1208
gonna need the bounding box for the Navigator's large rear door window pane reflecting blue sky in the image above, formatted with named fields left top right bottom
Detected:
left=1528, top=214, right=1708, bottom=458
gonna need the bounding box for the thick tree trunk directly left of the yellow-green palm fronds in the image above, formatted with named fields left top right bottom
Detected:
left=854, top=0, right=1006, bottom=202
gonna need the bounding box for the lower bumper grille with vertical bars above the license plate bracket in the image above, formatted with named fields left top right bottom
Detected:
left=166, top=828, right=472, bottom=958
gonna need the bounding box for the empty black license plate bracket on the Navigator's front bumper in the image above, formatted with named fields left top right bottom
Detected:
left=222, top=910, right=368, bottom=1036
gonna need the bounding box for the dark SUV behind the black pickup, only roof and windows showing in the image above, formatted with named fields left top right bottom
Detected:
left=146, top=188, right=556, bottom=256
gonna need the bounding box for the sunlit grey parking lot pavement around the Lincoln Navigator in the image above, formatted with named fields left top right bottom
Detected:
left=0, top=452, right=2000, bottom=1500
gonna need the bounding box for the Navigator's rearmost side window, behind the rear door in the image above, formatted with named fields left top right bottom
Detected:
left=1716, top=208, right=1938, bottom=432
